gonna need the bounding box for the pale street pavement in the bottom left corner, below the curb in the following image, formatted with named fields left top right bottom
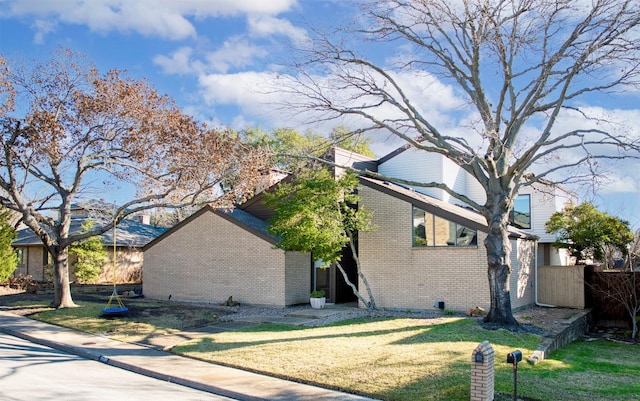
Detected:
left=0, top=333, right=235, bottom=401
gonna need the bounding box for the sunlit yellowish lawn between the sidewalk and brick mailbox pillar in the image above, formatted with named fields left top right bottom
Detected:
left=174, top=318, right=539, bottom=400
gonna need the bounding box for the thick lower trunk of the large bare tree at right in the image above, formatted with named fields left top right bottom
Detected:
left=484, top=216, right=519, bottom=326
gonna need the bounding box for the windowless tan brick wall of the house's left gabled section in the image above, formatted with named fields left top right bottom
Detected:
left=143, top=208, right=310, bottom=306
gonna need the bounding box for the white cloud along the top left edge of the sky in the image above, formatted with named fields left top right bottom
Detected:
left=3, top=0, right=296, bottom=40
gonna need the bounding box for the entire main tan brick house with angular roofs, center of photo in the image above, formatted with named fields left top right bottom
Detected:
left=143, top=148, right=537, bottom=310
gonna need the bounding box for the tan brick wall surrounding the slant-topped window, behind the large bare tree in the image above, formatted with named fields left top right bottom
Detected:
left=359, top=187, right=533, bottom=311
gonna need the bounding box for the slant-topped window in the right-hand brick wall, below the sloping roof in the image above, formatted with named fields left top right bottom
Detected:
left=413, top=206, right=478, bottom=247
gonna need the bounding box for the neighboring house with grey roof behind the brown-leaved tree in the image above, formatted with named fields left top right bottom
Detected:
left=11, top=205, right=167, bottom=283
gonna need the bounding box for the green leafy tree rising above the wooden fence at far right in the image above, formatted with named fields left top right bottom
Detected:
left=545, top=202, right=633, bottom=263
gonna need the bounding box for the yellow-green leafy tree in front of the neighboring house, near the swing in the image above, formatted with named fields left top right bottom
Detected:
left=69, top=220, right=108, bottom=284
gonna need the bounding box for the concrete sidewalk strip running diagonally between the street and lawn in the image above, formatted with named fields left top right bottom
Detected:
left=0, top=311, right=378, bottom=401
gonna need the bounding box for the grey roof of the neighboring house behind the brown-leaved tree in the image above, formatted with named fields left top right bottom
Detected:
left=11, top=219, right=167, bottom=248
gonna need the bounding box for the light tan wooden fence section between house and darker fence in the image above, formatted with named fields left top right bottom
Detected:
left=536, top=266, right=585, bottom=309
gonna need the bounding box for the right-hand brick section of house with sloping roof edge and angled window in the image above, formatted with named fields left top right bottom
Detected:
left=358, top=177, right=536, bottom=311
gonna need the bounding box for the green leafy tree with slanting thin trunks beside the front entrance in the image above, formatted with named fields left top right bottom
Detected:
left=265, top=168, right=376, bottom=309
